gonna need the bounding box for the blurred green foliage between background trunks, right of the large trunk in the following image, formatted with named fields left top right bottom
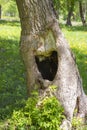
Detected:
left=53, top=0, right=87, bottom=21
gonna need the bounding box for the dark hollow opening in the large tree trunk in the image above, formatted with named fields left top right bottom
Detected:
left=35, top=51, right=58, bottom=81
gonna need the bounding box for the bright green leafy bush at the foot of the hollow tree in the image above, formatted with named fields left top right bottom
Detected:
left=9, top=93, right=65, bottom=130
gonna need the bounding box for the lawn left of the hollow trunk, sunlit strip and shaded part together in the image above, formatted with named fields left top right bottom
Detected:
left=0, top=21, right=27, bottom=120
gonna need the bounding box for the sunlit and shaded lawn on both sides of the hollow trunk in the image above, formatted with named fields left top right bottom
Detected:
left=0, top=21, right=87, bottom=126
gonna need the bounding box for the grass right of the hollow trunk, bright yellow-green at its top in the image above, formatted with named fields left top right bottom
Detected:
left=62, top=26, right=87, bottom=94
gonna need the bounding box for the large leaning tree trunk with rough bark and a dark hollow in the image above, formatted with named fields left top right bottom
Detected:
left=16, top=0, right=87, bottom=129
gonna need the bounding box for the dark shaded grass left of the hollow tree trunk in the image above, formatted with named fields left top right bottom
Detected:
left=0, top=39, right=27, bottom=120
